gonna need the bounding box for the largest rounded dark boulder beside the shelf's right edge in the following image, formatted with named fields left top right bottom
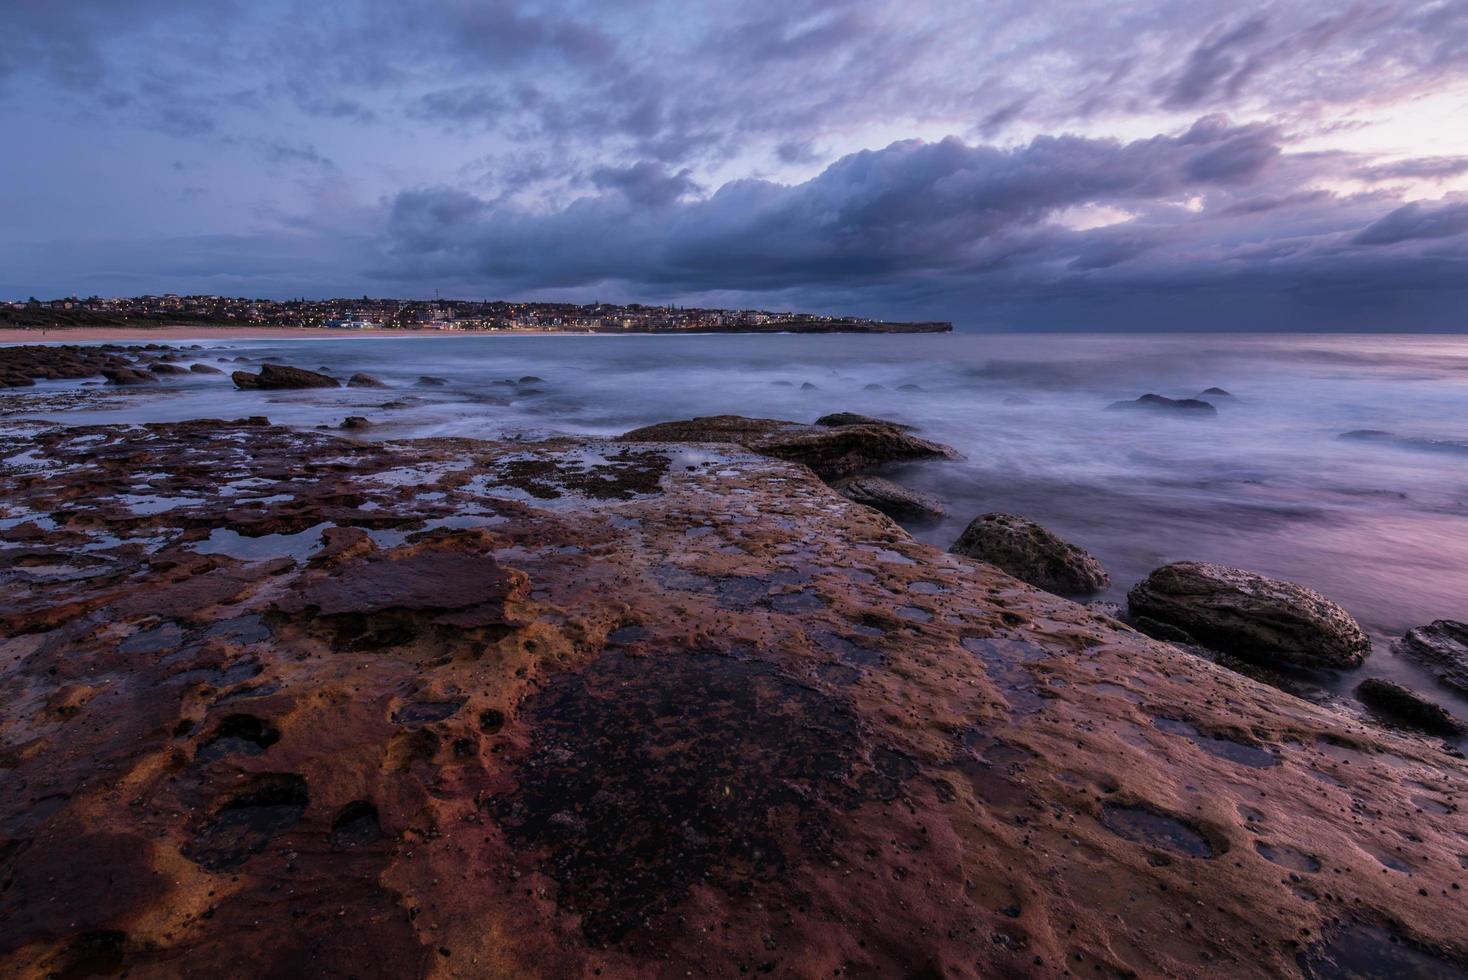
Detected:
left=1126, top=562, right=1371, bottom=668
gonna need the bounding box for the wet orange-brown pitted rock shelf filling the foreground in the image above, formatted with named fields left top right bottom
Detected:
left=0, top=347, right=1468, bottom=977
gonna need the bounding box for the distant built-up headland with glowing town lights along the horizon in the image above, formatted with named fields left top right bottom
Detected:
left=0, top=293, right=953, bottom=333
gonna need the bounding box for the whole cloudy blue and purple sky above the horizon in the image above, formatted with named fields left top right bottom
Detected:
left=0, top=0, right=1468, bottom=332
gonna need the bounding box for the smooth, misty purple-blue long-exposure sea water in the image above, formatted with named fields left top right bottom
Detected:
left=11, top=333, right=1468, bottom=700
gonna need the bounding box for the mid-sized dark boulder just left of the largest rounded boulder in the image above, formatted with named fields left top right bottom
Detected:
left=948, top=513, right=1111, bottom=596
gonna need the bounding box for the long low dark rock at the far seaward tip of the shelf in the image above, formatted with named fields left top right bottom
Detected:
left=622, top=415, right=957, bottom=480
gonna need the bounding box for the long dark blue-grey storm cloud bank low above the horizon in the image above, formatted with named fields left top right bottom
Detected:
left=379, top=117, right=1468, bottom=326
